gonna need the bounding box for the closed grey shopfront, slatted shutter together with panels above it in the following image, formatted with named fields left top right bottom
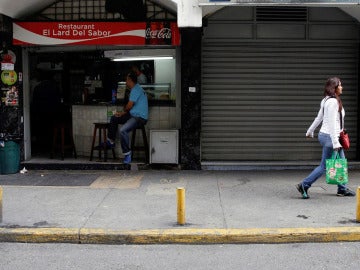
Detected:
left=201, top=7, right=359, bottom=163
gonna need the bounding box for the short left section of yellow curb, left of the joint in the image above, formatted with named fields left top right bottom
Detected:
left=0, top=228, right=79, bottom=244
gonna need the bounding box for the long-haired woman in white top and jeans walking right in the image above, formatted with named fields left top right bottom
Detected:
left=296, top=77, right=355, bottom=199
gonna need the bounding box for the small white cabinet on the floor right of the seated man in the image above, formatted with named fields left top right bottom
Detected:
left=150, top=129, right=179, bottom=164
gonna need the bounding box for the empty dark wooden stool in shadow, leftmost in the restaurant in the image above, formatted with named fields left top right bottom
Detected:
left=50, top=122, right=77, bottom=160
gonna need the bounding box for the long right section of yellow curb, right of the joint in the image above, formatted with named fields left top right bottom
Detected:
left=80, top=227, right=360, bottom=244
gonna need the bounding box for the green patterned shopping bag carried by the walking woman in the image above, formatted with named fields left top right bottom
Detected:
left=326, top=151, right=348, bottom=185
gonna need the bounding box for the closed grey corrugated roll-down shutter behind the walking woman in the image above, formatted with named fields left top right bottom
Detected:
left=201, top=40, right=358, bottom=161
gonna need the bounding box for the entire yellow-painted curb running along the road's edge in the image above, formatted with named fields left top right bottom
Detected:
left=0, top=227, right=360, bottom=244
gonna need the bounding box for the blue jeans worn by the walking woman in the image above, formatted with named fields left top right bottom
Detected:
left=302, top=132, right=346, bottom=191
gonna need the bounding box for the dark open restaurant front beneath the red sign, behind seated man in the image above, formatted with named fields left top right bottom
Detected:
left=28, top=47, right=179, bottom=161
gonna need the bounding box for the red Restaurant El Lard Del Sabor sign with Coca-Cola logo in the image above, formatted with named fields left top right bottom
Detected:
left=13, top=22, right=180, bottom=46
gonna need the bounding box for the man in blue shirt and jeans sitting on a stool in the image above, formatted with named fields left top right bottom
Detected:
left=107, top=72, right=149, bottom=164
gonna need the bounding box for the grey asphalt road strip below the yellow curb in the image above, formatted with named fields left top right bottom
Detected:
left=0, top=242, right=360, bottom=270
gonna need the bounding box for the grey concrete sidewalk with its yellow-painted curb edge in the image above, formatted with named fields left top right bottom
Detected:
left=0, top=170, right=360, bottom=244
